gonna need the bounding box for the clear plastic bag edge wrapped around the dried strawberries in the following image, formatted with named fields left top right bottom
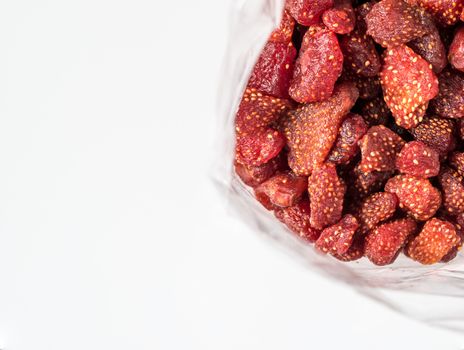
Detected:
left=214, top=0, right=464, bottom=332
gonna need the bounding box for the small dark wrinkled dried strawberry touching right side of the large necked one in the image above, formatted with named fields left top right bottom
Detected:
left=328, top=113, right=367, bottom=164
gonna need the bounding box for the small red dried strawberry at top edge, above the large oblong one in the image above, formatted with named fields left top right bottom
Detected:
left=322, top=0, right=356, bottom=34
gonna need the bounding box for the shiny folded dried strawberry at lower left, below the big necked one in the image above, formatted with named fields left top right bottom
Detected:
left=255, top=172, right=308, bottom=210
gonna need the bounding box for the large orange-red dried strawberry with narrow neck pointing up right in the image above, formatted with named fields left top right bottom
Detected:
left=281, top=83, right=358, bottom=175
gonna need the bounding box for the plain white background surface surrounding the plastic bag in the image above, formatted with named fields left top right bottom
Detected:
left=0, top=0, right=464, bottom=350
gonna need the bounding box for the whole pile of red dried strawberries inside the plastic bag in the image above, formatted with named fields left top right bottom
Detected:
left=235, top=0, right=464, bottom=265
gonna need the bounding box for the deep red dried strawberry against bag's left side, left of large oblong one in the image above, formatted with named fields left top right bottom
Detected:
left=248, top=41, right=296, bottom=98
